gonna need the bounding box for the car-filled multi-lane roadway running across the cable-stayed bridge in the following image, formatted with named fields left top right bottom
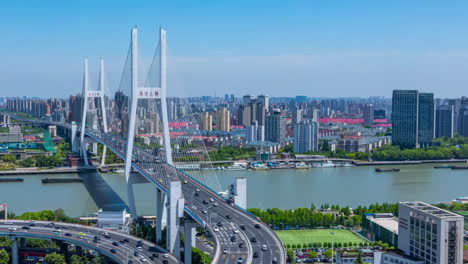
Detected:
left=8, top=119, right=286, bottom=264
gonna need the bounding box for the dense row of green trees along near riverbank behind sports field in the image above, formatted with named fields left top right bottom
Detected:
left=248, top=203, right=398, bottom=228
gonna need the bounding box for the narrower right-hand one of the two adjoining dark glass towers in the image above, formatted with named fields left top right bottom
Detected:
left=418, top=93, right=435, bottom=147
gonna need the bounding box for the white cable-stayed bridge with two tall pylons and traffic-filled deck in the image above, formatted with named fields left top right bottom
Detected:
left=8, top=28, right=286, bottom=263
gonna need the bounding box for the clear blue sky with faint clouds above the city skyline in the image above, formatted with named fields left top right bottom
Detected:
left=0, top=0, right=468, bottom=97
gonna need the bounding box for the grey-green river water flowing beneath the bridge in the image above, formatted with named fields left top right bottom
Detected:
left=0, top=164, right=468, bottom=217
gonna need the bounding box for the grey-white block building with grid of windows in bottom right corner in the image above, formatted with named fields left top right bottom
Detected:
left=398, top=202, right=464, bottom=264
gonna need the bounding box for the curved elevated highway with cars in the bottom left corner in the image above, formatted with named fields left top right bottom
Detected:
left=0, top=220, right=179, bottom=264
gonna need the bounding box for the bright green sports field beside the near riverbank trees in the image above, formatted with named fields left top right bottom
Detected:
left=275, top=229, right=366, bottom=245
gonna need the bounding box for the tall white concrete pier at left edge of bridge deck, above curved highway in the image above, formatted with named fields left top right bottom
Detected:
left=166, top=181, right=184, bottom=258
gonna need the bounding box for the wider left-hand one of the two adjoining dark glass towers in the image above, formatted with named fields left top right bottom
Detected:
left=392, top=90, right=419, bottom=148
